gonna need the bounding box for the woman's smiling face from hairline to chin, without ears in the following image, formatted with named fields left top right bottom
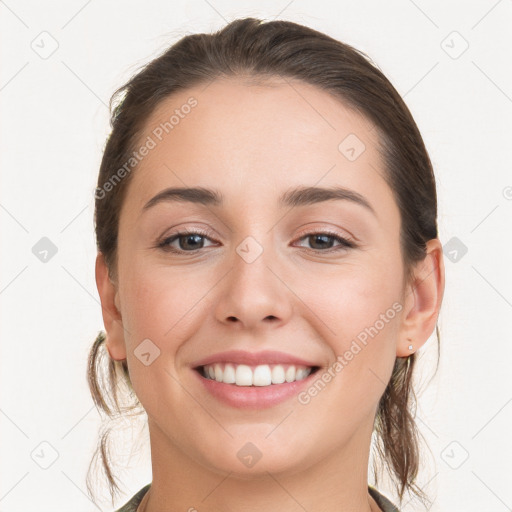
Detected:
left=100, top=79, right=416, bottom=476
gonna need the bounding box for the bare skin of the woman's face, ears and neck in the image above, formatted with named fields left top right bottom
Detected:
left=96, top=79, right=444, bottom=512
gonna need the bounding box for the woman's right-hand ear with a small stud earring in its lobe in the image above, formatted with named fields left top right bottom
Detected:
left=396, top=238, right=445, bottom=357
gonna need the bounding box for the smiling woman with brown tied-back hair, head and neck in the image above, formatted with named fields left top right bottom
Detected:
left=89, top=18, right=444, bottom=512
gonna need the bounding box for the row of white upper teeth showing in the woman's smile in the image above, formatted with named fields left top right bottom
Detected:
left=202, top=363, right=312, bottom=386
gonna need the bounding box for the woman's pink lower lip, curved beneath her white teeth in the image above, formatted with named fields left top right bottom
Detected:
left=193, top=370, right=317, bottom=409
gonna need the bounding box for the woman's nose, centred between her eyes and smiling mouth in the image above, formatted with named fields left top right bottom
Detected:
left=216, top=237, right=293, bottom=330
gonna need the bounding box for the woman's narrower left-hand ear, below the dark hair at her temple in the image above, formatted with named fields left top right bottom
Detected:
left=96, top=252, right=126, bottom=361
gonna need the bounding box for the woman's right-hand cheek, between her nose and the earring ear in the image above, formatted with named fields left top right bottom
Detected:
left=304, top=262, right=403, bottom=390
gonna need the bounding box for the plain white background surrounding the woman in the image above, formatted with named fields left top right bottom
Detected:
left=0, top=0, right=512, bottom=512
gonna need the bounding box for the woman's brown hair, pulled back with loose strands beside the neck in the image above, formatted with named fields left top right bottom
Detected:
left=87, top=18, right=439, bottom=504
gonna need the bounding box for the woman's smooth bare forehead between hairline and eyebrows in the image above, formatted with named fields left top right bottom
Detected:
left=122, top=75, right=396, bottom=222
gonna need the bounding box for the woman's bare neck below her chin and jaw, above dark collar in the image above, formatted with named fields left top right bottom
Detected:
left=138, top=420, right=380, bottom=512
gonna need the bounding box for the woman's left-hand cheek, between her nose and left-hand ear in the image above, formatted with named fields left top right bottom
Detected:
left=118, top=260, right=205, bottom=410
